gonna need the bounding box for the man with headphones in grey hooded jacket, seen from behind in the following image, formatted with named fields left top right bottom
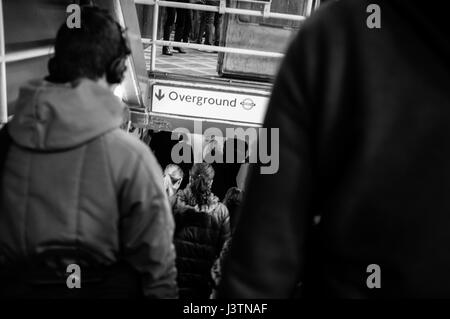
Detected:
left=0, top=7, right=177, bottom=298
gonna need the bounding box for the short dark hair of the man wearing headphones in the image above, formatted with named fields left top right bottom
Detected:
left=47, top=6, right=130, bottom=83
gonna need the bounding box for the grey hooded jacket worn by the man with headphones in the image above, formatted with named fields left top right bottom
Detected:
left=0, top=80, right=177, bottom=298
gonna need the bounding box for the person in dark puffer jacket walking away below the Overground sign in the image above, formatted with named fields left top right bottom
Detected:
left=173, top=163, right=230, bottom=299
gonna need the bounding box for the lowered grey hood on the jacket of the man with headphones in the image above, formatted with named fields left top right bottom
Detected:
left=9, top=79, right=124, bottom=151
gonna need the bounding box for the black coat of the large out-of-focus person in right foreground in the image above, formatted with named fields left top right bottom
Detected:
left=222, top=0, right=450, bottom=298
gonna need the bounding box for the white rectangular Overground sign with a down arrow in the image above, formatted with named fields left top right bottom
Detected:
left=152, top=84, right=269, bottom=124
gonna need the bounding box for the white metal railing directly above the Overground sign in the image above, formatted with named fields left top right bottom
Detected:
left=135, top=0, right=313, bottom=72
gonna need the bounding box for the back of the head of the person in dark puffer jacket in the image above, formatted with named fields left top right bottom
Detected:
left=189, top=163, right=214, bottom=206
